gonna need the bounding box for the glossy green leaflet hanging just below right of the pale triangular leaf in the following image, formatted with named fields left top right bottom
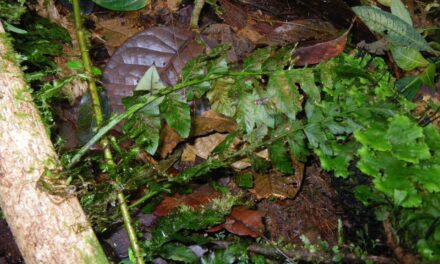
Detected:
left=160, top=96, right=191, bottom=138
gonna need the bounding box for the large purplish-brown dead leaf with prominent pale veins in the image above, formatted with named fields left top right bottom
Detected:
left=102, top=27, right=204, bottom=112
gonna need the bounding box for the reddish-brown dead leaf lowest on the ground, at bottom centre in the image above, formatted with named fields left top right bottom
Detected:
left=208, top=206, right=264, bottom=238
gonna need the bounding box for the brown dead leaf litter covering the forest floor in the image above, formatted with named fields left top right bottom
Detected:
left=6, top=0, right=436, bottom=262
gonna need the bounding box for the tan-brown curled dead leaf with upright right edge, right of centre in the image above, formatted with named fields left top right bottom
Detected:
left=251, top=159, right=304, bottom=199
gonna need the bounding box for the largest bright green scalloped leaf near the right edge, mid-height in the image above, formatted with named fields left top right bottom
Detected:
left=387, top=115, right=431, bottom=163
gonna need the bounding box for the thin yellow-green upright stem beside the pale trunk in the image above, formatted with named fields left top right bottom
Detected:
left=72, top=0, right=144, bottom=264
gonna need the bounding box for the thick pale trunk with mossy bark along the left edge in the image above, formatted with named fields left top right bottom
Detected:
left=0, top=23, right=108, bottom=264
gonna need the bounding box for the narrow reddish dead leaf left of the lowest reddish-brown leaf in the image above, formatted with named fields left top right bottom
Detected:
left=153, top=184, right=220, bottom=217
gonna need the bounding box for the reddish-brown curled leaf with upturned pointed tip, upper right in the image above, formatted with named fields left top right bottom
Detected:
left=293, top=30, right=350, bottom=66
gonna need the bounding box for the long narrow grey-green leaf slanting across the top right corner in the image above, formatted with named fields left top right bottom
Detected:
left=353, top=6, right=434, bottom=52
